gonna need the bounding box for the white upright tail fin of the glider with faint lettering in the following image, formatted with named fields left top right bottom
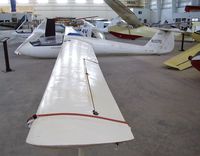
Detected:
left=145, top=30, right=174, bottom=54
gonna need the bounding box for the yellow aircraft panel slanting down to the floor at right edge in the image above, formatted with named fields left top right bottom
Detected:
left=164, top=44, right=200, bottom=70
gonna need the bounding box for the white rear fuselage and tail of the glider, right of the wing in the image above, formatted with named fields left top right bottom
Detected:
left=67, top=31, right=174, bottom=55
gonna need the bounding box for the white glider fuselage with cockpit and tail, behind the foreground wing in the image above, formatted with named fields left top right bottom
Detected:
left=15, top=18, right=174, bottom=58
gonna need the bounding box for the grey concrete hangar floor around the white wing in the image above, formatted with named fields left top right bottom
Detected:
left=0, top=34, right=200, bottom=156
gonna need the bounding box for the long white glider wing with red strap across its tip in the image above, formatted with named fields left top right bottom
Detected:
left=26, top=39, right=133, bottom=147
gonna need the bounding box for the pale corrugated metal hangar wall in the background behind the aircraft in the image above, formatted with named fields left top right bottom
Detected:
left=0, top=0, right=200, bottom=23
